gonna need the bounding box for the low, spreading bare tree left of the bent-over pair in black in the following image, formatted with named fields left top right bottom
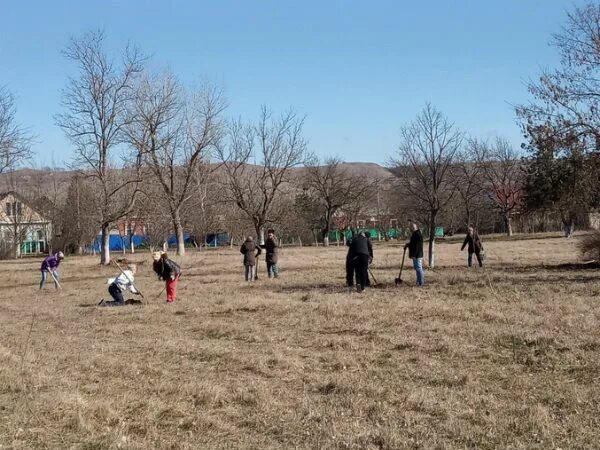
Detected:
left=304, top=158, right=375, bottom=246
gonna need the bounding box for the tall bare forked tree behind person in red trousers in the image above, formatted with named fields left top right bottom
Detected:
left=128, top=75, right=225, bottom=255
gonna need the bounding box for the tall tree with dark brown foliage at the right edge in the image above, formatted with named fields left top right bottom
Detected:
left=516, top=2, right=600, bottom=237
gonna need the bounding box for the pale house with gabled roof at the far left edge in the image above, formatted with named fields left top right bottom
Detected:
left=0, top=191, right=52, bottom=258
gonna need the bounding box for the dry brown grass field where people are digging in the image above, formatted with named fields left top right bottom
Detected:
left=0, top=235, right=600, bottom=450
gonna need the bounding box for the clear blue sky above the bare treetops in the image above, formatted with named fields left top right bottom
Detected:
left=0, top=0, right=582, bottom=166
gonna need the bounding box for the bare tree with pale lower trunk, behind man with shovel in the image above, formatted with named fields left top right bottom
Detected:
left=392, top=104, right=463, bottom=267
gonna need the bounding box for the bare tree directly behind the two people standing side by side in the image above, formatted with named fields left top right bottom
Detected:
left=216, top=107, right=306, bottom=237
